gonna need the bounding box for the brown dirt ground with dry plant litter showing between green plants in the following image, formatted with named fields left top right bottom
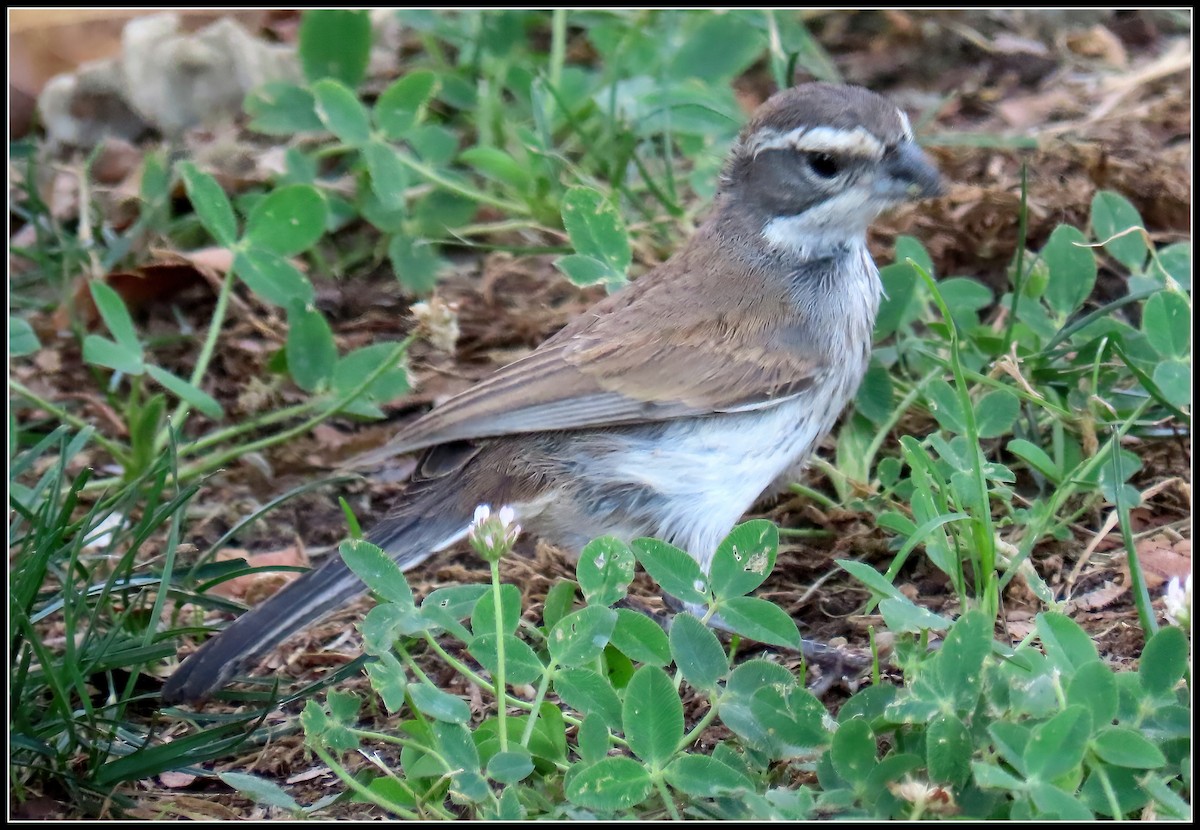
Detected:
left=12, top=11, right=1192, bottom=819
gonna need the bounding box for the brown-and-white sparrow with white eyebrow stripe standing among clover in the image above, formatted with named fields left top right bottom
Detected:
left=162, top=83, right=943, bottom=704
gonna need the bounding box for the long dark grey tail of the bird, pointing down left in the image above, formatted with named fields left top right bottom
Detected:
left=162, top=503, right=470, bottom=704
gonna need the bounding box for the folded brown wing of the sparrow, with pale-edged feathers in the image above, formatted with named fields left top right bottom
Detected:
left=353, top=327, right=823, bottom=467
